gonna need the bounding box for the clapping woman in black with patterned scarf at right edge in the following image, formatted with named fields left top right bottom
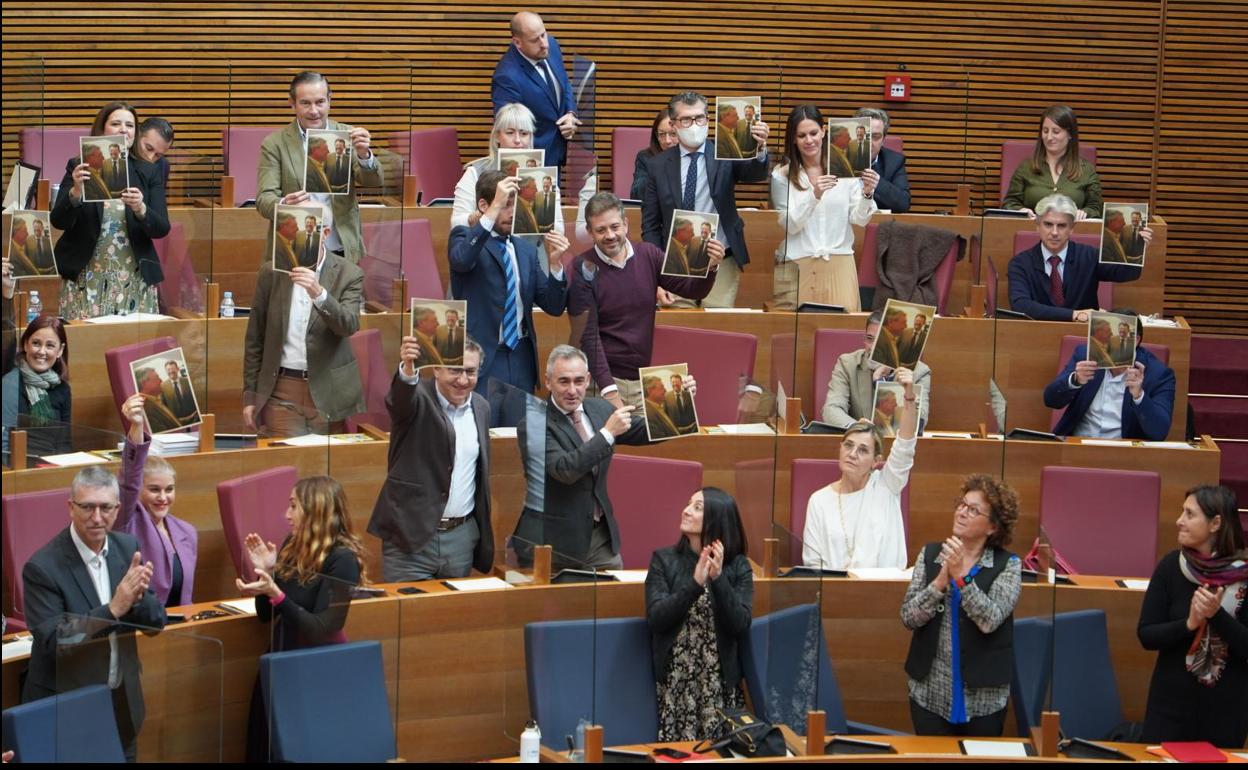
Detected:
left=1138, top=487, right=1248, bottom=749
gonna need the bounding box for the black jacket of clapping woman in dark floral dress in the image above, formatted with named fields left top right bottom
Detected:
left=645, top=545, right=754, bottom=689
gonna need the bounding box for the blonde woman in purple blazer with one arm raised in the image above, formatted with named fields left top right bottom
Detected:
left=112, top=393, right=200, bottom=607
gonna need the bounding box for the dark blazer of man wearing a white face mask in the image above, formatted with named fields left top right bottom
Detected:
left=641, top=140, right=768, bottom=267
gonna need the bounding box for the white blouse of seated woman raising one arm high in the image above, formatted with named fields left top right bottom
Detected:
left=801, top=431, right=917, bottom=569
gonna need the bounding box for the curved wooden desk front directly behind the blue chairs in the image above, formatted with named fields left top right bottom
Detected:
left=2, top=579, right=1154, bottom=761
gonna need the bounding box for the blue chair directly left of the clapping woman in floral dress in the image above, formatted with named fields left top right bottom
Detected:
left=514, top=618, right=659, bottom=749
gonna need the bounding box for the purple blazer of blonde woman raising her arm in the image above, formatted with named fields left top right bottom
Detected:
left=112, top=436, right=200, bottom=607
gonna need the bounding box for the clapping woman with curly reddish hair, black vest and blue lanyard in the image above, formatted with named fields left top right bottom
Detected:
left=901, top=473, right=1022, bottom=736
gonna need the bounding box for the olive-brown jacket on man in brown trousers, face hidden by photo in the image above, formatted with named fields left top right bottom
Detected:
left=242, top=253, right=364, bottom=422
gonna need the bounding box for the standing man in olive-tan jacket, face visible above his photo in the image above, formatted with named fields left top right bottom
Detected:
left=256, top=71, right=382, bottom=265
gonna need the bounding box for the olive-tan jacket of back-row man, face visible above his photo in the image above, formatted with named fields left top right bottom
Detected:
left=256, top=120, right=382, bottom=263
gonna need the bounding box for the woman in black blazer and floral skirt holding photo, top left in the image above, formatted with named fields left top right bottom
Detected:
left=51, top=101, right=168, bottom=321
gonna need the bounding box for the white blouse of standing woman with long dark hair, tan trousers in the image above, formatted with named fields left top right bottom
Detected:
left=771, top=166, right=879, bottom=262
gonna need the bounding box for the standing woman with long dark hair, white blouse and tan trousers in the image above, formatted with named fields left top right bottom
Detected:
left=771, top=105, right=880, bottom=313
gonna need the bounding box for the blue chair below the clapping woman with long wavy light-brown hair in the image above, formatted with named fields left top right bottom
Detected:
left=260, top=641, right=396, bottom=763
